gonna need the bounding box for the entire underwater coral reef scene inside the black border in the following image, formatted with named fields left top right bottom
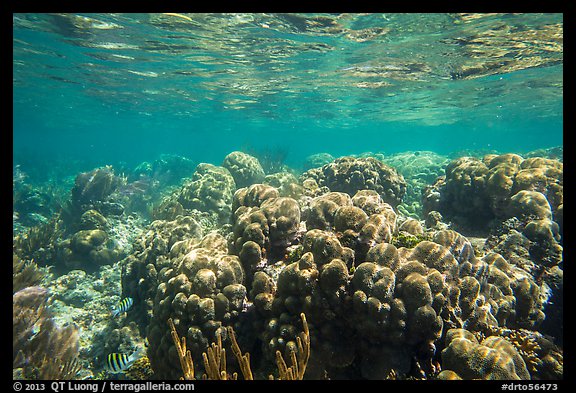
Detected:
left=12, top=13, right=564, bottom=381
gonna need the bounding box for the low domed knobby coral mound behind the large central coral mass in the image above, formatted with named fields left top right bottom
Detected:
left=301, top=157, right=406, bottom=206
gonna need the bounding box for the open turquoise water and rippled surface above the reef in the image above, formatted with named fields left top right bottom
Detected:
left=13, top=14, right=563, bottom=166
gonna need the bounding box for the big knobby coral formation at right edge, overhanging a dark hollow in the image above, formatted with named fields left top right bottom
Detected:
left=423, top=154, right=563, bottom=333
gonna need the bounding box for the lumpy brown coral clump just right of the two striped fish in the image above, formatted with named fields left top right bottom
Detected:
left=148, top=233, right=246, bottom=378
